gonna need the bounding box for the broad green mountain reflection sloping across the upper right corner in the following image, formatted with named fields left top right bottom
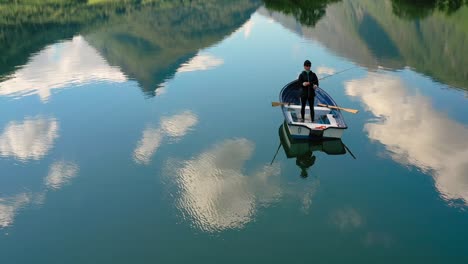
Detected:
left=259, top=0, right=468, bottom=89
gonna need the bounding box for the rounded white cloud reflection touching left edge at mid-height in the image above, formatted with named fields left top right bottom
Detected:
left=0, top=117, right=58, bottom=161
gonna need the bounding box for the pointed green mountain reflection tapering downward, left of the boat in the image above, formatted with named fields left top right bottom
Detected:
left=82, top=0, right=260, bottom=95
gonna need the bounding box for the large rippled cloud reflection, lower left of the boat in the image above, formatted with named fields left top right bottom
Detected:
left=167, top=139, right=281, bottom=232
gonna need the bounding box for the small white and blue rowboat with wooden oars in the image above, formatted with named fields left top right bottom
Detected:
left=279, top=81, right=348, bottom=139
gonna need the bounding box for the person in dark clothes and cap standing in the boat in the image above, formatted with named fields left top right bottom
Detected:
left=298, top=60, right=318, bottom=122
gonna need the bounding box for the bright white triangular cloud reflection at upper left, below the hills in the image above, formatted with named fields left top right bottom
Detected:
left=0, top=36, right=126, bottom=102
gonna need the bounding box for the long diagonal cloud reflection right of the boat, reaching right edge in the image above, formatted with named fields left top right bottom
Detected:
left=346, top=74, right=468, bottom=204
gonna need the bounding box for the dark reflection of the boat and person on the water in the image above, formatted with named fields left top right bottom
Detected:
left=278, top=123, right=348, bottom=178
